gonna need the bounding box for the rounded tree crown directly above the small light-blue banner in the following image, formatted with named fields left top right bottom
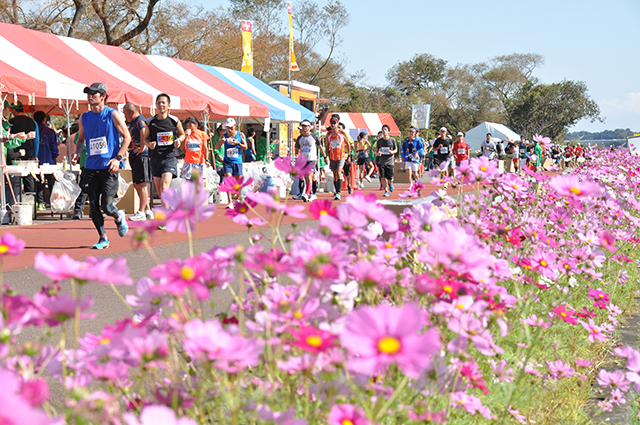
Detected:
left=387, top=53, right=447, bottom=95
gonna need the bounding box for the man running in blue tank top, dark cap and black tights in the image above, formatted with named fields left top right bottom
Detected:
left=73, top=83, right=131, bottom=249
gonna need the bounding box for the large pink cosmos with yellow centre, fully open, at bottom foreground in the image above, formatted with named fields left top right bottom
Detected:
left=340, top=304, right=441, bottom=379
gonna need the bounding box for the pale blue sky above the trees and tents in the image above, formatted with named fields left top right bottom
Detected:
left=201, top=0, right=640, bottom=131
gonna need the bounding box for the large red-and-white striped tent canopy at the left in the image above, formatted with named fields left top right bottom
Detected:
left=0, top=23, right=269, bottom=119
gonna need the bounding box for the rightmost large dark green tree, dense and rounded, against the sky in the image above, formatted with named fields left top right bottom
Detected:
left=506, top=80, right=603, bottom=139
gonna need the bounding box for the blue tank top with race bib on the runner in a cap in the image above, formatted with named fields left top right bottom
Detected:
left=82, top=106, right=120, bottom=170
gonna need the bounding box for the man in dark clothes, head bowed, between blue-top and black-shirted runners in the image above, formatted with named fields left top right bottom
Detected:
left=122, top=103, right=153, bottom=221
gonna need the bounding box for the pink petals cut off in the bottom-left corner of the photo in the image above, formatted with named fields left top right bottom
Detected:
left=0, top=368, right=56, bottom=425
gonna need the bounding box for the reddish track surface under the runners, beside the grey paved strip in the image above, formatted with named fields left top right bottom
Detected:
left=0, top=180, right=473, bottom=271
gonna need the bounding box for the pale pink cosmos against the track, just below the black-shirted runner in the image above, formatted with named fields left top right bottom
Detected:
left=158, top=177, right=216, bottom=233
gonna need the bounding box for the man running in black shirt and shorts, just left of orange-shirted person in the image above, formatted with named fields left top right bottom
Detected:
left=145, top=93, right=186, bottom=211
